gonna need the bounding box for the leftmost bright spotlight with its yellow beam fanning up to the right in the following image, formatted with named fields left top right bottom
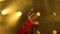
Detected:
left=1, top=2, right=18, bottom=15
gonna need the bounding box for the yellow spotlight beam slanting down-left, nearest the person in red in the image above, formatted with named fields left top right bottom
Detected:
left=7, top=12, right=22, bottom=26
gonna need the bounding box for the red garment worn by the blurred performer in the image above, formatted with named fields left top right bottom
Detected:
left=18, top=18, right=34, bottom=34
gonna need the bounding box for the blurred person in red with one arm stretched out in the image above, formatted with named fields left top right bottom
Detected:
left=18, top=12, right=40, bottom=34
